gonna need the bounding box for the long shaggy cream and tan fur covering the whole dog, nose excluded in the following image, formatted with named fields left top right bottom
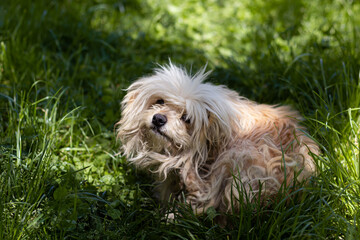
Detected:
left=117, top=63, right=318, bottom=213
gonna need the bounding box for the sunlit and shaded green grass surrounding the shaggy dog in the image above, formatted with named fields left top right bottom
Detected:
left=0, top=0, right=360, bottom=239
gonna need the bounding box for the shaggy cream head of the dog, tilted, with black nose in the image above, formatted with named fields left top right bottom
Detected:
left=117, top=63, right=240, bottom=170
